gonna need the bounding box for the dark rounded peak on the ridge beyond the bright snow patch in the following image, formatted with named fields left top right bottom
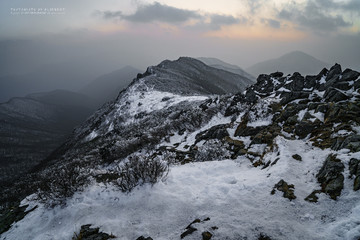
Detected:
left=137, top=57, right=253, bottom=95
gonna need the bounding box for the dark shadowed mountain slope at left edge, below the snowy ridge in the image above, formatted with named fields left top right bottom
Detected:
left=0, top=90, right=96, bottom=185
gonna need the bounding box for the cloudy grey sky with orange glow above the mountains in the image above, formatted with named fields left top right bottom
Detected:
left=0, top=0, right=360, bottom=73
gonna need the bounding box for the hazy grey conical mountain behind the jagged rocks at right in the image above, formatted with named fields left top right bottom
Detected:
left=246, top=51, right=330, bottom=77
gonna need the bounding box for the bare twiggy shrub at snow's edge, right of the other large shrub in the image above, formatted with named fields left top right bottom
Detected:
left=114, top=156, right=169, bottom=192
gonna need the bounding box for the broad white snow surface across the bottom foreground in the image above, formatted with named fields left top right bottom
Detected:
left=1, top=137, right=360, bottom=240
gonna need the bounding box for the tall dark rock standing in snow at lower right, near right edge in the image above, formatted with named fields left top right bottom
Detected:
left=316, top=154, right=344, bottom=200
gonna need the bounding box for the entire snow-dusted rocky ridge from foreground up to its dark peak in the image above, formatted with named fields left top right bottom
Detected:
left=1, top=58, right=360, bottom=240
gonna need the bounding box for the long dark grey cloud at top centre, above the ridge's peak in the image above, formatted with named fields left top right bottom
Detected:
left=100, top=2, right=243, bottom=29
